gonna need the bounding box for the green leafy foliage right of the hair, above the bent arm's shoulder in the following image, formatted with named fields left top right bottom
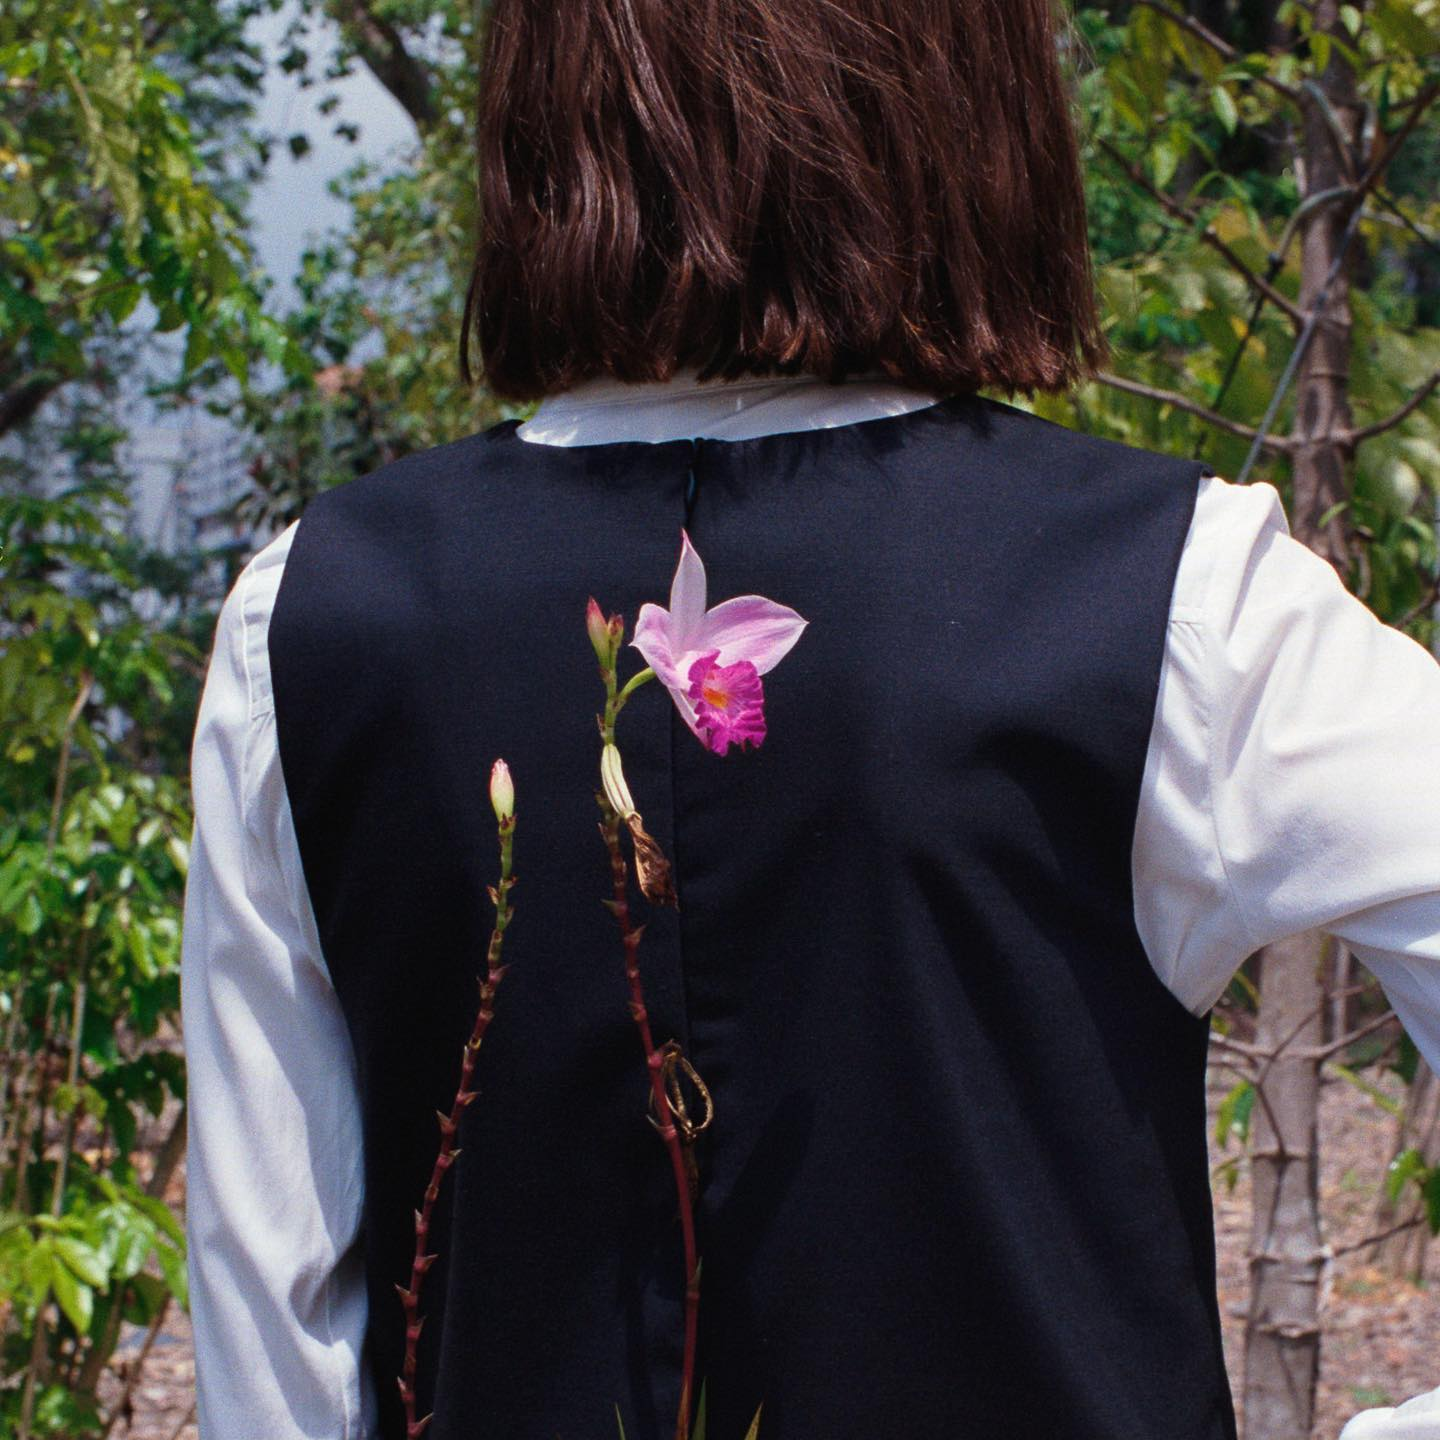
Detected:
left=1037, top=0, right=1440, bottom=641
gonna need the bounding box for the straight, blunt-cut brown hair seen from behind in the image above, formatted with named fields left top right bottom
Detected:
left=461, top=0, right=1104, bottom=400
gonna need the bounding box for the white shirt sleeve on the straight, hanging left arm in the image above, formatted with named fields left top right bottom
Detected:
left=180, top=521, right=376, bottom=1440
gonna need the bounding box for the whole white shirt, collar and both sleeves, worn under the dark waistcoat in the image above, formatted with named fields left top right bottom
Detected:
left=181, top=373, right=1440, bottom=1440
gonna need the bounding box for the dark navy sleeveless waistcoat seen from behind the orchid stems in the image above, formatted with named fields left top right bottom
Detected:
left=269, top=396, right=1236, bottom=1440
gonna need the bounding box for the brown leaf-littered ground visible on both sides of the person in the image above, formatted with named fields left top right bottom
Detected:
left=112, top=1070, right=1440, bottom=1440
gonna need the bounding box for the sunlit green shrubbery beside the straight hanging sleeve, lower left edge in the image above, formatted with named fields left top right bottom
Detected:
left=0, top=487, right=200, bottom=1437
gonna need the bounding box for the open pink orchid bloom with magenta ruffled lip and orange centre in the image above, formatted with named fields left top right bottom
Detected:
left=631, top=530, right=809, bottom=755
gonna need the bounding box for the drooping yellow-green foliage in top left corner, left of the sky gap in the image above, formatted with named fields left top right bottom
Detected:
left=0, top=0, right=305, bottom=432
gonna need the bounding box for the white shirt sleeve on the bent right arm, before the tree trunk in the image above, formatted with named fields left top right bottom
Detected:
left=1133, top=477, right=1440, bottom=1440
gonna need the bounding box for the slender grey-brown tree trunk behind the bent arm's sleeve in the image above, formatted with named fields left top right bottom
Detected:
left=1244, top=8, right=1361, bottom=1440
